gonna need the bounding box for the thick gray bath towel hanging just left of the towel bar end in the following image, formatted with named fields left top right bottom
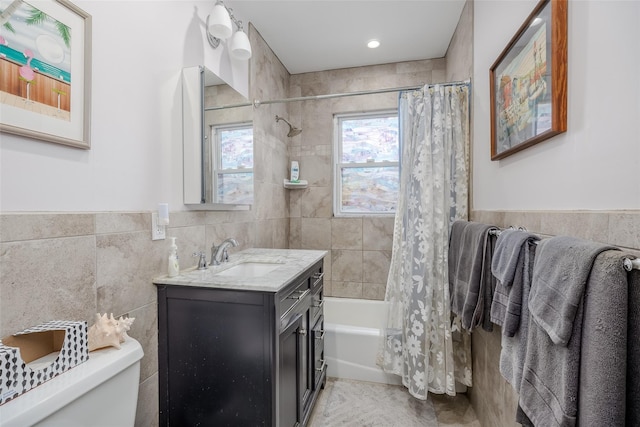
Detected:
left=578, top=251, right=637, bottom=426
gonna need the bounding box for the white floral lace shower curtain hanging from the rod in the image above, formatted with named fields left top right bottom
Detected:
left=378, top=83, right=471, bottom=399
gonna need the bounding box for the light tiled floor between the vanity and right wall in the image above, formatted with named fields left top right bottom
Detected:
left=308, top=378, right=480, bottom=427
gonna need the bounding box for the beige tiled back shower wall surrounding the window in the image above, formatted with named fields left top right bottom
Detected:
left=289, top=58, right=445, bottom=300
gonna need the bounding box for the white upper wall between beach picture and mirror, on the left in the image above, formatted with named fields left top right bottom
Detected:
left=0, top=1, right=248, bottom=212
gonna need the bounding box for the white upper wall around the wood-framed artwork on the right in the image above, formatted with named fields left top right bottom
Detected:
left=473, top=0, right=640, bottom=210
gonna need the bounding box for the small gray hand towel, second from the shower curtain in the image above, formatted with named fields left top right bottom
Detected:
left=491, top=230, right=540, bottom=337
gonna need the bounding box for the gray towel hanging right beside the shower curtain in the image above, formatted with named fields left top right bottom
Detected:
left=449, top=221, right=498, bottom=330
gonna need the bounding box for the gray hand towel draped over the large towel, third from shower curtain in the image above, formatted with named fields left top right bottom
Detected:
left=529, top=236, right=616, bottom=345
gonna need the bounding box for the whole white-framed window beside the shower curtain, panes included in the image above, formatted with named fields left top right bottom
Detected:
left=334, top=110, right=400, bottom=216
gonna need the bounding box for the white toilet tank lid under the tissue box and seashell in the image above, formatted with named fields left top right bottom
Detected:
left=0, top=336, right=144, bottom=427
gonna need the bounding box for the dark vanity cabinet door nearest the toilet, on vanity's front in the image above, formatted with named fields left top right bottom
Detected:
left=278, top=314, right=306, bottom=427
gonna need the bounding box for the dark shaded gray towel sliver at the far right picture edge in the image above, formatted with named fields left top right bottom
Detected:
left=626, top=270, right=640, bottom=426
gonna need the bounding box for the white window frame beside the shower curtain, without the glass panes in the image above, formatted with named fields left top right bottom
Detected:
left=332, top=109, right=402, bottom=218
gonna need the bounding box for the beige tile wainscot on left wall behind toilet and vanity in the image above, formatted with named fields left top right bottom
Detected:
left=0, top=211, right=286, bottom=426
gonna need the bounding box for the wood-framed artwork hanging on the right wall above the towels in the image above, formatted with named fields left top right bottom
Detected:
left=490, top=0, right=567, bottom=160
